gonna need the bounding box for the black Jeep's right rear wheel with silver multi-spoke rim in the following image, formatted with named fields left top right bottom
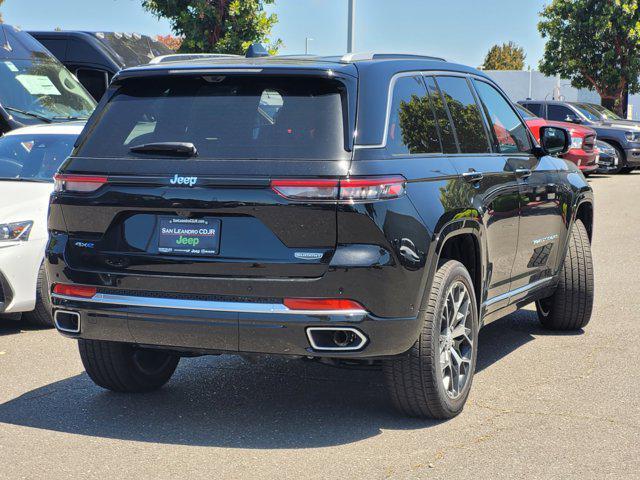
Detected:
left=383, top=260, right=478, bottom=419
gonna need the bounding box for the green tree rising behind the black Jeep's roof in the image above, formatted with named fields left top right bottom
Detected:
left=142, top=0, right=282, bottom=55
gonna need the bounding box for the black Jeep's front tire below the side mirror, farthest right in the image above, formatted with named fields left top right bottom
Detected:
left=536, top=220, right=593, bottom=330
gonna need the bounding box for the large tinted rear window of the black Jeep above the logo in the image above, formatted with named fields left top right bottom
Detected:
left=78, top=75, right=348, bottom=160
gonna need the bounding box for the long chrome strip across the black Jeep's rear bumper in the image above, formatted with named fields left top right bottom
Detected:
left=51, top=293, right=367, bottom=316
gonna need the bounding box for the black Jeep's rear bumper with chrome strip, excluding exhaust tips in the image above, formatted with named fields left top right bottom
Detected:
left=52, top=294, right=421, bottom=358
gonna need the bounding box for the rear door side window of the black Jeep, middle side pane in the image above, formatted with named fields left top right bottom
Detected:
left=436, top=77, right=490, bottom=153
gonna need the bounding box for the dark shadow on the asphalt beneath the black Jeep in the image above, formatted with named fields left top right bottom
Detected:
left=0, top=311, right=580, bottom=449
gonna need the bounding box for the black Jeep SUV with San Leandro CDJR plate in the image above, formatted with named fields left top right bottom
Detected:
left=46, top=54, right=593, bottom=418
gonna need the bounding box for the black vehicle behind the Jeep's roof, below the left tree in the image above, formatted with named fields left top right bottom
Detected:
left=29, top=30, right=174, bottom=100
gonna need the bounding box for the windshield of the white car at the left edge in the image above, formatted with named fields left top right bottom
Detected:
left=0, top=134, right=77, bottom=182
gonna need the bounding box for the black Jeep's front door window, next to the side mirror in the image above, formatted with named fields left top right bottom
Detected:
left=473, top=80, right=531, bottom=153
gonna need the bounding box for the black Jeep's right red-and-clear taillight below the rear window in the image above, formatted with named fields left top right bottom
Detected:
left=271, top=176, right=407, bottom=203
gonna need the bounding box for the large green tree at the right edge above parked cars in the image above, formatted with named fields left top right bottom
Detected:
left=538, top=0, right=640, bottom=115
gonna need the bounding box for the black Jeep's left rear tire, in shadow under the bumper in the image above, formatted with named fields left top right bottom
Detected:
left=78, top=339, right=180, bottom=393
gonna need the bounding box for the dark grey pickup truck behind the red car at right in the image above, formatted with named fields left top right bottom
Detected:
left=518, top=100, right=640, bottom=173
